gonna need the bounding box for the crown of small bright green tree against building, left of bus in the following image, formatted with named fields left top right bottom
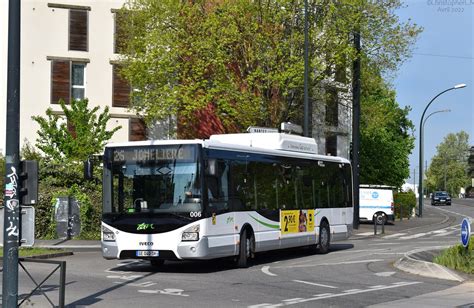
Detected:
left=32, top=99, right=121, bottom=161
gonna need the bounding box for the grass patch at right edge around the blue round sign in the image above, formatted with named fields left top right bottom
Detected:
left=433, top=238, right=474, bottom=274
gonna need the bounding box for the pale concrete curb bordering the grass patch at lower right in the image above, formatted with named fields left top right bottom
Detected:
left=393, top=246, right=465, bottom=282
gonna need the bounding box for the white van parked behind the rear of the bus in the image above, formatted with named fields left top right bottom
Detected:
left=359, top=185, right=395, bottom=224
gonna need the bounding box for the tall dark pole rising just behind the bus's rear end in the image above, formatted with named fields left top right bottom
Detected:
left=352, top=29, right=361, bottom=229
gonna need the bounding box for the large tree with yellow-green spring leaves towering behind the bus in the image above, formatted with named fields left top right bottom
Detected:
left=119, top=0, right=420, bottom=137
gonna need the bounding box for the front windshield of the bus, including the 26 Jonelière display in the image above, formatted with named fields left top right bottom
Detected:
left=104, top=145, right=202, bottom=217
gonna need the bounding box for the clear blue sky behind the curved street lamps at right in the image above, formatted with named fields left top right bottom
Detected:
left=392, top=0, right=474, bottom=183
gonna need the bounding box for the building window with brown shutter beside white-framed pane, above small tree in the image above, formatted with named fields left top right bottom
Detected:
left=51, top=59, right=86, bottom=104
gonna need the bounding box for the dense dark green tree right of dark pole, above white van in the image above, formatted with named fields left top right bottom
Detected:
left=360, top=69, right=415, bottom=187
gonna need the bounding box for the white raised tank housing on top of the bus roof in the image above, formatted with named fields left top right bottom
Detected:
left=209, top=132, right=318, bottom=154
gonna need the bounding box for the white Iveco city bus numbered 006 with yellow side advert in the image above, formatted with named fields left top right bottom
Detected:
left=102, top=127, right=353, bottom=267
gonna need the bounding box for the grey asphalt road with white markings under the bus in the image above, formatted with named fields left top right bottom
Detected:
left=3, top=200, right=474, bottom=308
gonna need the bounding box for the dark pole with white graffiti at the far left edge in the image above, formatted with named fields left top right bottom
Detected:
left=2, top=0, right=21, bottom=308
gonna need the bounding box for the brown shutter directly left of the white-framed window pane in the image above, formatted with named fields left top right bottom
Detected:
left=51, top=60, right=71, bottom=104
